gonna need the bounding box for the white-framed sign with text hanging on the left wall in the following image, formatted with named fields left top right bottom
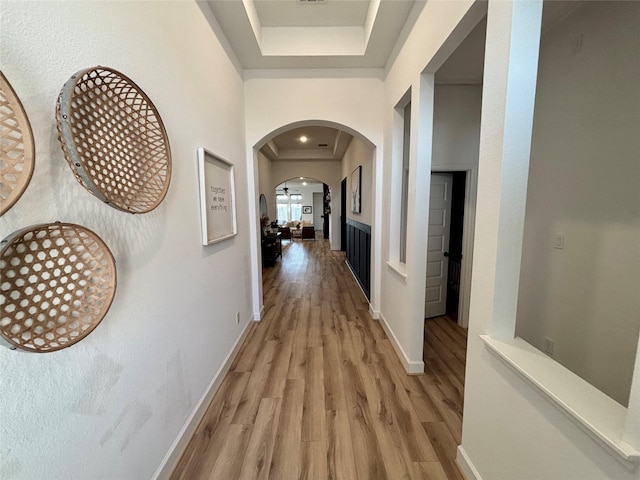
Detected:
left=198, top=147, right=238, bottom=245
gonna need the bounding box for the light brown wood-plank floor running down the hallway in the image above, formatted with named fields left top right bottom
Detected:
left=171, top=239, right=466, bottom=480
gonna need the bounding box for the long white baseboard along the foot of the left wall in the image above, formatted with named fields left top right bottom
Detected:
left=152, top=322, right=252, bottom=480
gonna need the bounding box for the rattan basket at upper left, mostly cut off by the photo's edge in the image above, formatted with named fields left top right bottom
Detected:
left=0, top=72, right=35, bottom=215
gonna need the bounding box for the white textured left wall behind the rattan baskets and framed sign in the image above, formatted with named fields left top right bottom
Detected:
left=0, top=2, right=251, bottom=479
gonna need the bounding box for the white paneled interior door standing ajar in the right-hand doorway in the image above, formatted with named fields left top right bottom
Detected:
left=424, top=173, right=453, bottom=318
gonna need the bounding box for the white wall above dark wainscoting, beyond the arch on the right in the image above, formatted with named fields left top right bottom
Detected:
left=336, top=137, right=374, bottom=225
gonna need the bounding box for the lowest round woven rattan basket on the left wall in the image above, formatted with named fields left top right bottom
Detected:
left=0, top=223, right=116, bottom=352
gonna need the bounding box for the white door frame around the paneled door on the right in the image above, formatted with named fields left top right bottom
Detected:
left=429, top=165, right=478, bottom=328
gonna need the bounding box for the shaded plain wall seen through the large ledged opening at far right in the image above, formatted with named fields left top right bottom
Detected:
left=517, top=2, right=640, bottom=406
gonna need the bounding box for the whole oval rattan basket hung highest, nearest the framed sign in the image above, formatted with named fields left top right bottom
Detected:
left=56, top=67, right=171, bottom=213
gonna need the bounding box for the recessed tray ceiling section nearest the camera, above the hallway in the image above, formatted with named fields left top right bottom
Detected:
left=206, top=0, right=418, bottom=70
